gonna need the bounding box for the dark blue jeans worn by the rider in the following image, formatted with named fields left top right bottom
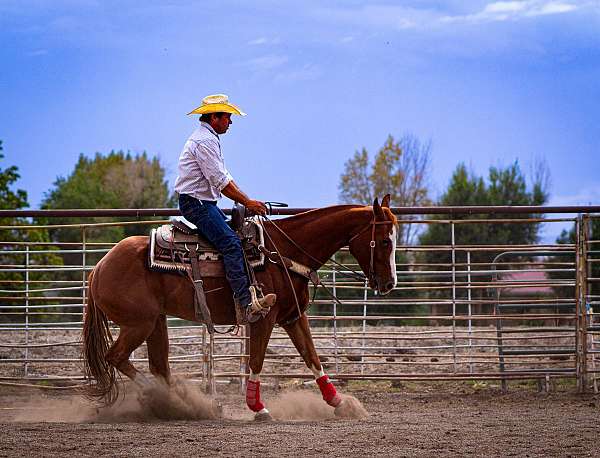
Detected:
left=179, top=194, right=251, bottom=307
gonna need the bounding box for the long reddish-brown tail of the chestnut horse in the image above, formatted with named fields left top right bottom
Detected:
left=82, top=271, right=119, bottom=405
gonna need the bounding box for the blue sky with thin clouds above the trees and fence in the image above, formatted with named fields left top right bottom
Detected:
left=0, top=0, right=600, bottom=240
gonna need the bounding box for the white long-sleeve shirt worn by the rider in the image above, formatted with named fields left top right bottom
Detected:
left=175, top=121, right=233, bottom=200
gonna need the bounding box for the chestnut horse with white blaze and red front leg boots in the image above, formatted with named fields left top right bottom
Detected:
left=83, top=195, right=397, bottom=417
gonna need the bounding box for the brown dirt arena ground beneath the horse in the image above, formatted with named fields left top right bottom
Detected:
left=0, top=382, right=600, bottom=457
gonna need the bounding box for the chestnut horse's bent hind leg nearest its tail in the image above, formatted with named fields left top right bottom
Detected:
left=106, top=322, right=155, bottom=387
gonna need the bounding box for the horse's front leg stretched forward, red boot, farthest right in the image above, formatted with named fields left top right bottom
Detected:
left=284, top=314, right=342, bottom=407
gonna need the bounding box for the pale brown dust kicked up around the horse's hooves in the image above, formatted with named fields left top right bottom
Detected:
left=13, top=380, right=368, bottom=423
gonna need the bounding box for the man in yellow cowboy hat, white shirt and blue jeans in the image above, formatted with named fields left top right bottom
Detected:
left=175, top=94, right=276, bottom=323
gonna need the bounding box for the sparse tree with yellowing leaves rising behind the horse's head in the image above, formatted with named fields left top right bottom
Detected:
left=338, top=134, right=431, bottom=243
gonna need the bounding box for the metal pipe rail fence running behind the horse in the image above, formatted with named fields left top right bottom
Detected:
left=0, top=206, right=600, bottom=392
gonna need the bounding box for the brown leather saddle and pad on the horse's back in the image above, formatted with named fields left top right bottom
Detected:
left=148, top=217, right=265, bottom=277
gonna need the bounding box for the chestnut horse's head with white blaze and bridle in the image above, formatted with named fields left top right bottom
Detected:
left=348, top=194, right=398, bottom=295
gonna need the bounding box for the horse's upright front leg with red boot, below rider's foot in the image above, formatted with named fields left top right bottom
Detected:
left=246, top=314, right=275, bottom=421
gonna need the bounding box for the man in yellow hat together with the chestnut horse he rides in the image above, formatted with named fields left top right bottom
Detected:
left=82, top=95, right=398, bottom=419
